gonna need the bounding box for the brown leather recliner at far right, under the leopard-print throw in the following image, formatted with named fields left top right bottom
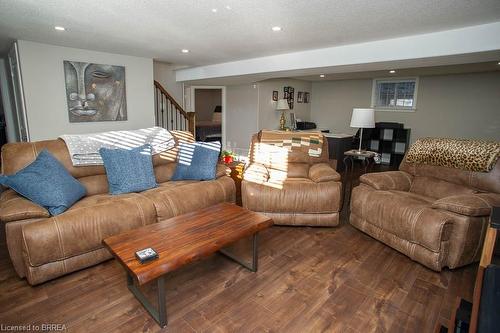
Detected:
left=350, top=153, right=500, bottom=271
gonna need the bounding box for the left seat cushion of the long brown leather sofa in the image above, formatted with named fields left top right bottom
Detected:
left=22, top=193, right=156, bottom=266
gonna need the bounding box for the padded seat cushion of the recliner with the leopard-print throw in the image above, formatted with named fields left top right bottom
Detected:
left=351, top=184, right=452, bottom=252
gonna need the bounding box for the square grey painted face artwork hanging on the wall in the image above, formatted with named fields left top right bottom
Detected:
left=64, top=61, right=127, bottom=123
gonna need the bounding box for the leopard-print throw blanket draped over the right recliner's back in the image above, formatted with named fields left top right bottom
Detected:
left=406, top=138, right=500, bottom=172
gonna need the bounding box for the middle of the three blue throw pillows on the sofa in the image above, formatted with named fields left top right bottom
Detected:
left=99, top=144, right=158, bottom=194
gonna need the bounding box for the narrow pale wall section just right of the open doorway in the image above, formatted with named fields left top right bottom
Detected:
left=225, top=84, right=259, bottom=149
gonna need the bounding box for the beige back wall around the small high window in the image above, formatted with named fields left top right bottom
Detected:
left=311, top=72, right=500, bottom=142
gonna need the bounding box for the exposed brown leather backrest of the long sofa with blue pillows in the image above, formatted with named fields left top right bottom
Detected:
left=1, top=131, right=194, bottom=196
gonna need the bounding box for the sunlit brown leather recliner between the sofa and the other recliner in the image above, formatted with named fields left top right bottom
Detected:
left=241, top=134, right=342, bottom=226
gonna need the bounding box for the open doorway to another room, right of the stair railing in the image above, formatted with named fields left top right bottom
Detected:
left=191, top=86, right=226, bottom=147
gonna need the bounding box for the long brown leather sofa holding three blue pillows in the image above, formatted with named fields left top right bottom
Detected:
left=0, top=132, right=235, bottom=285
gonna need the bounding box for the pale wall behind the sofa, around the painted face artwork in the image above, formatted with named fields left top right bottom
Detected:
left=18, top=40, right=154, bottom=141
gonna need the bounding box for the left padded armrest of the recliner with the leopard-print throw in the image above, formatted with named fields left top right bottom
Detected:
left=359, top=171, right=413, bottom=192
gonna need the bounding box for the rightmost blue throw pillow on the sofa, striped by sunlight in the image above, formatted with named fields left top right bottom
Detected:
left=172, top=141, right=221, bottom=180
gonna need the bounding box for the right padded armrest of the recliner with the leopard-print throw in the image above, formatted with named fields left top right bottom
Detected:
left=432, top=194, right=492, bottom=216
